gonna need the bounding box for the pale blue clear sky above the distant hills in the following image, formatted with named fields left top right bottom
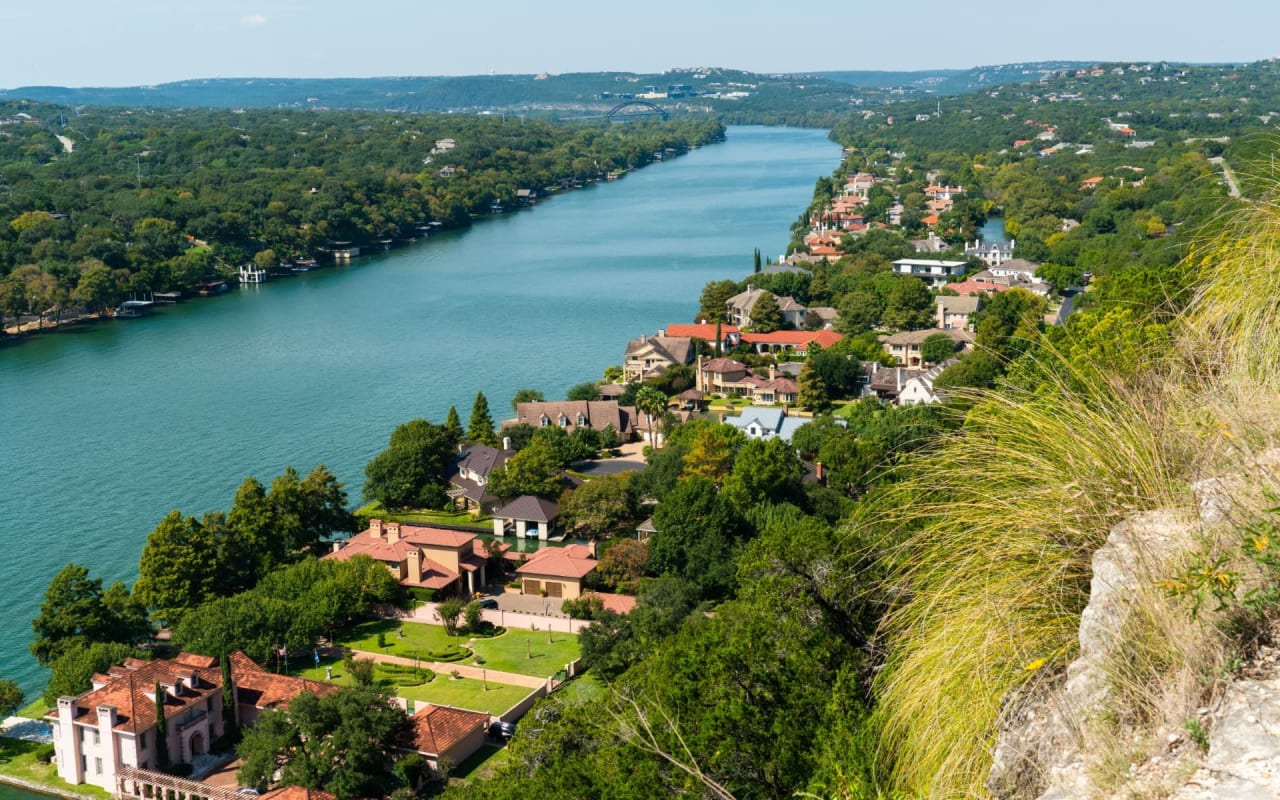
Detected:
left=0, top=0, right=1280, bottom=88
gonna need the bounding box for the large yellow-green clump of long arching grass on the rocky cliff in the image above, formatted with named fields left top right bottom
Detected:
left=874, top=188, right=1280, bottom=797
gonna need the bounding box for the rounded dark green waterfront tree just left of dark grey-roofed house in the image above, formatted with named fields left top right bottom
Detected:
left=365, top=420, right=458, bottom=508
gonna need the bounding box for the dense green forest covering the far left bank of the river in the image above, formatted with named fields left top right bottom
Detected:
left=0, top=102, right=723, bottom=325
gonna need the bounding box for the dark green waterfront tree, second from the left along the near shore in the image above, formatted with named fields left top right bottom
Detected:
left=133, top=511, right=218, bottom=625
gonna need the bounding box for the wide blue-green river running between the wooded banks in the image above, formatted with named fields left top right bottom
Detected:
left=0, top=128, right=840, bottom=691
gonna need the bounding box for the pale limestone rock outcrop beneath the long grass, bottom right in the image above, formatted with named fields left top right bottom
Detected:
left=987, top=499, right=1280, bottom=800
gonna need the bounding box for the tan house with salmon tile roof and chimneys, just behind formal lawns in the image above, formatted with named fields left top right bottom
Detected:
left=324, top=520, right=507, bottom=596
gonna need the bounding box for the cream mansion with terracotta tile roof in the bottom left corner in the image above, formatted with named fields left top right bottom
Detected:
left=46, top=653, right=327, bottom=792
